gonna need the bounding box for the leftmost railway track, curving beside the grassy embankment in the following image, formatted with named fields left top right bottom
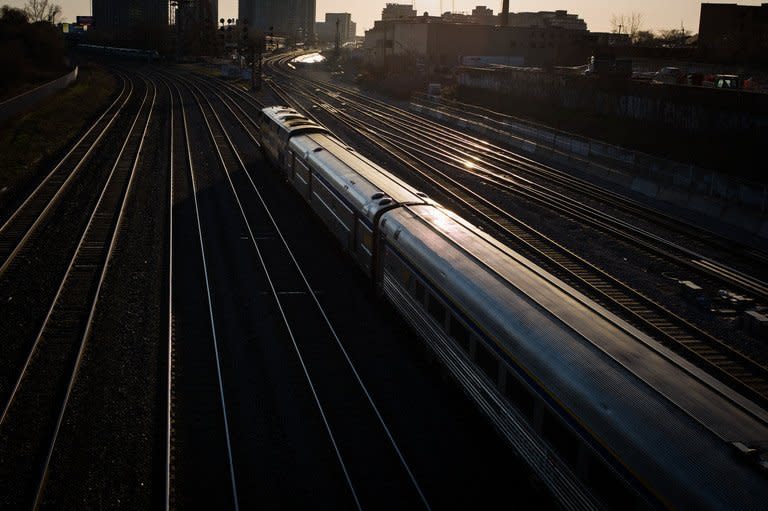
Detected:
left=0, top=72, right=134, bottom=277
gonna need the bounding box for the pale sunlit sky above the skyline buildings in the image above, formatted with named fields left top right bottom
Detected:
left=12, top=0, right=766, bottom=35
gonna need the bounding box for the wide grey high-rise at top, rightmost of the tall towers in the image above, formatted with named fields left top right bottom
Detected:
left=238, top=0, right=316, bottom=41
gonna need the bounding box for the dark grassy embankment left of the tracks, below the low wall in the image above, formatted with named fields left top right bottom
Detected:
left=0, top=65, right=117, bottom=198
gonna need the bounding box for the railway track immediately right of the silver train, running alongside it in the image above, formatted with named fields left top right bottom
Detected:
left=255, top=66, right=768, bottom=414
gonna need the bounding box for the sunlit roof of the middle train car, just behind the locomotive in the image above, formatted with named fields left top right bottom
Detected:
left=290, top=133, right=432, bottom=221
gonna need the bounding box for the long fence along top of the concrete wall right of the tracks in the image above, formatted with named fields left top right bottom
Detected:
left=412, top=95, right=768, bottom=222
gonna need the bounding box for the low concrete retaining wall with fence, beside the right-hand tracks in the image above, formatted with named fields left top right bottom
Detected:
left=411, top=98, right=768, bottom=238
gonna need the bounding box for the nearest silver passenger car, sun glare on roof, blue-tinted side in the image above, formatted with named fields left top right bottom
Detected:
left=382, top=207, right=768, bottom=509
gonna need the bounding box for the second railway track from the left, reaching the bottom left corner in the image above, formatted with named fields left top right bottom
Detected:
left=0, top=75, right=157, bottom=509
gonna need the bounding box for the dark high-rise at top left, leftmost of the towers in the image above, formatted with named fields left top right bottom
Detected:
left=92, top=0, right=168, bottom=48
